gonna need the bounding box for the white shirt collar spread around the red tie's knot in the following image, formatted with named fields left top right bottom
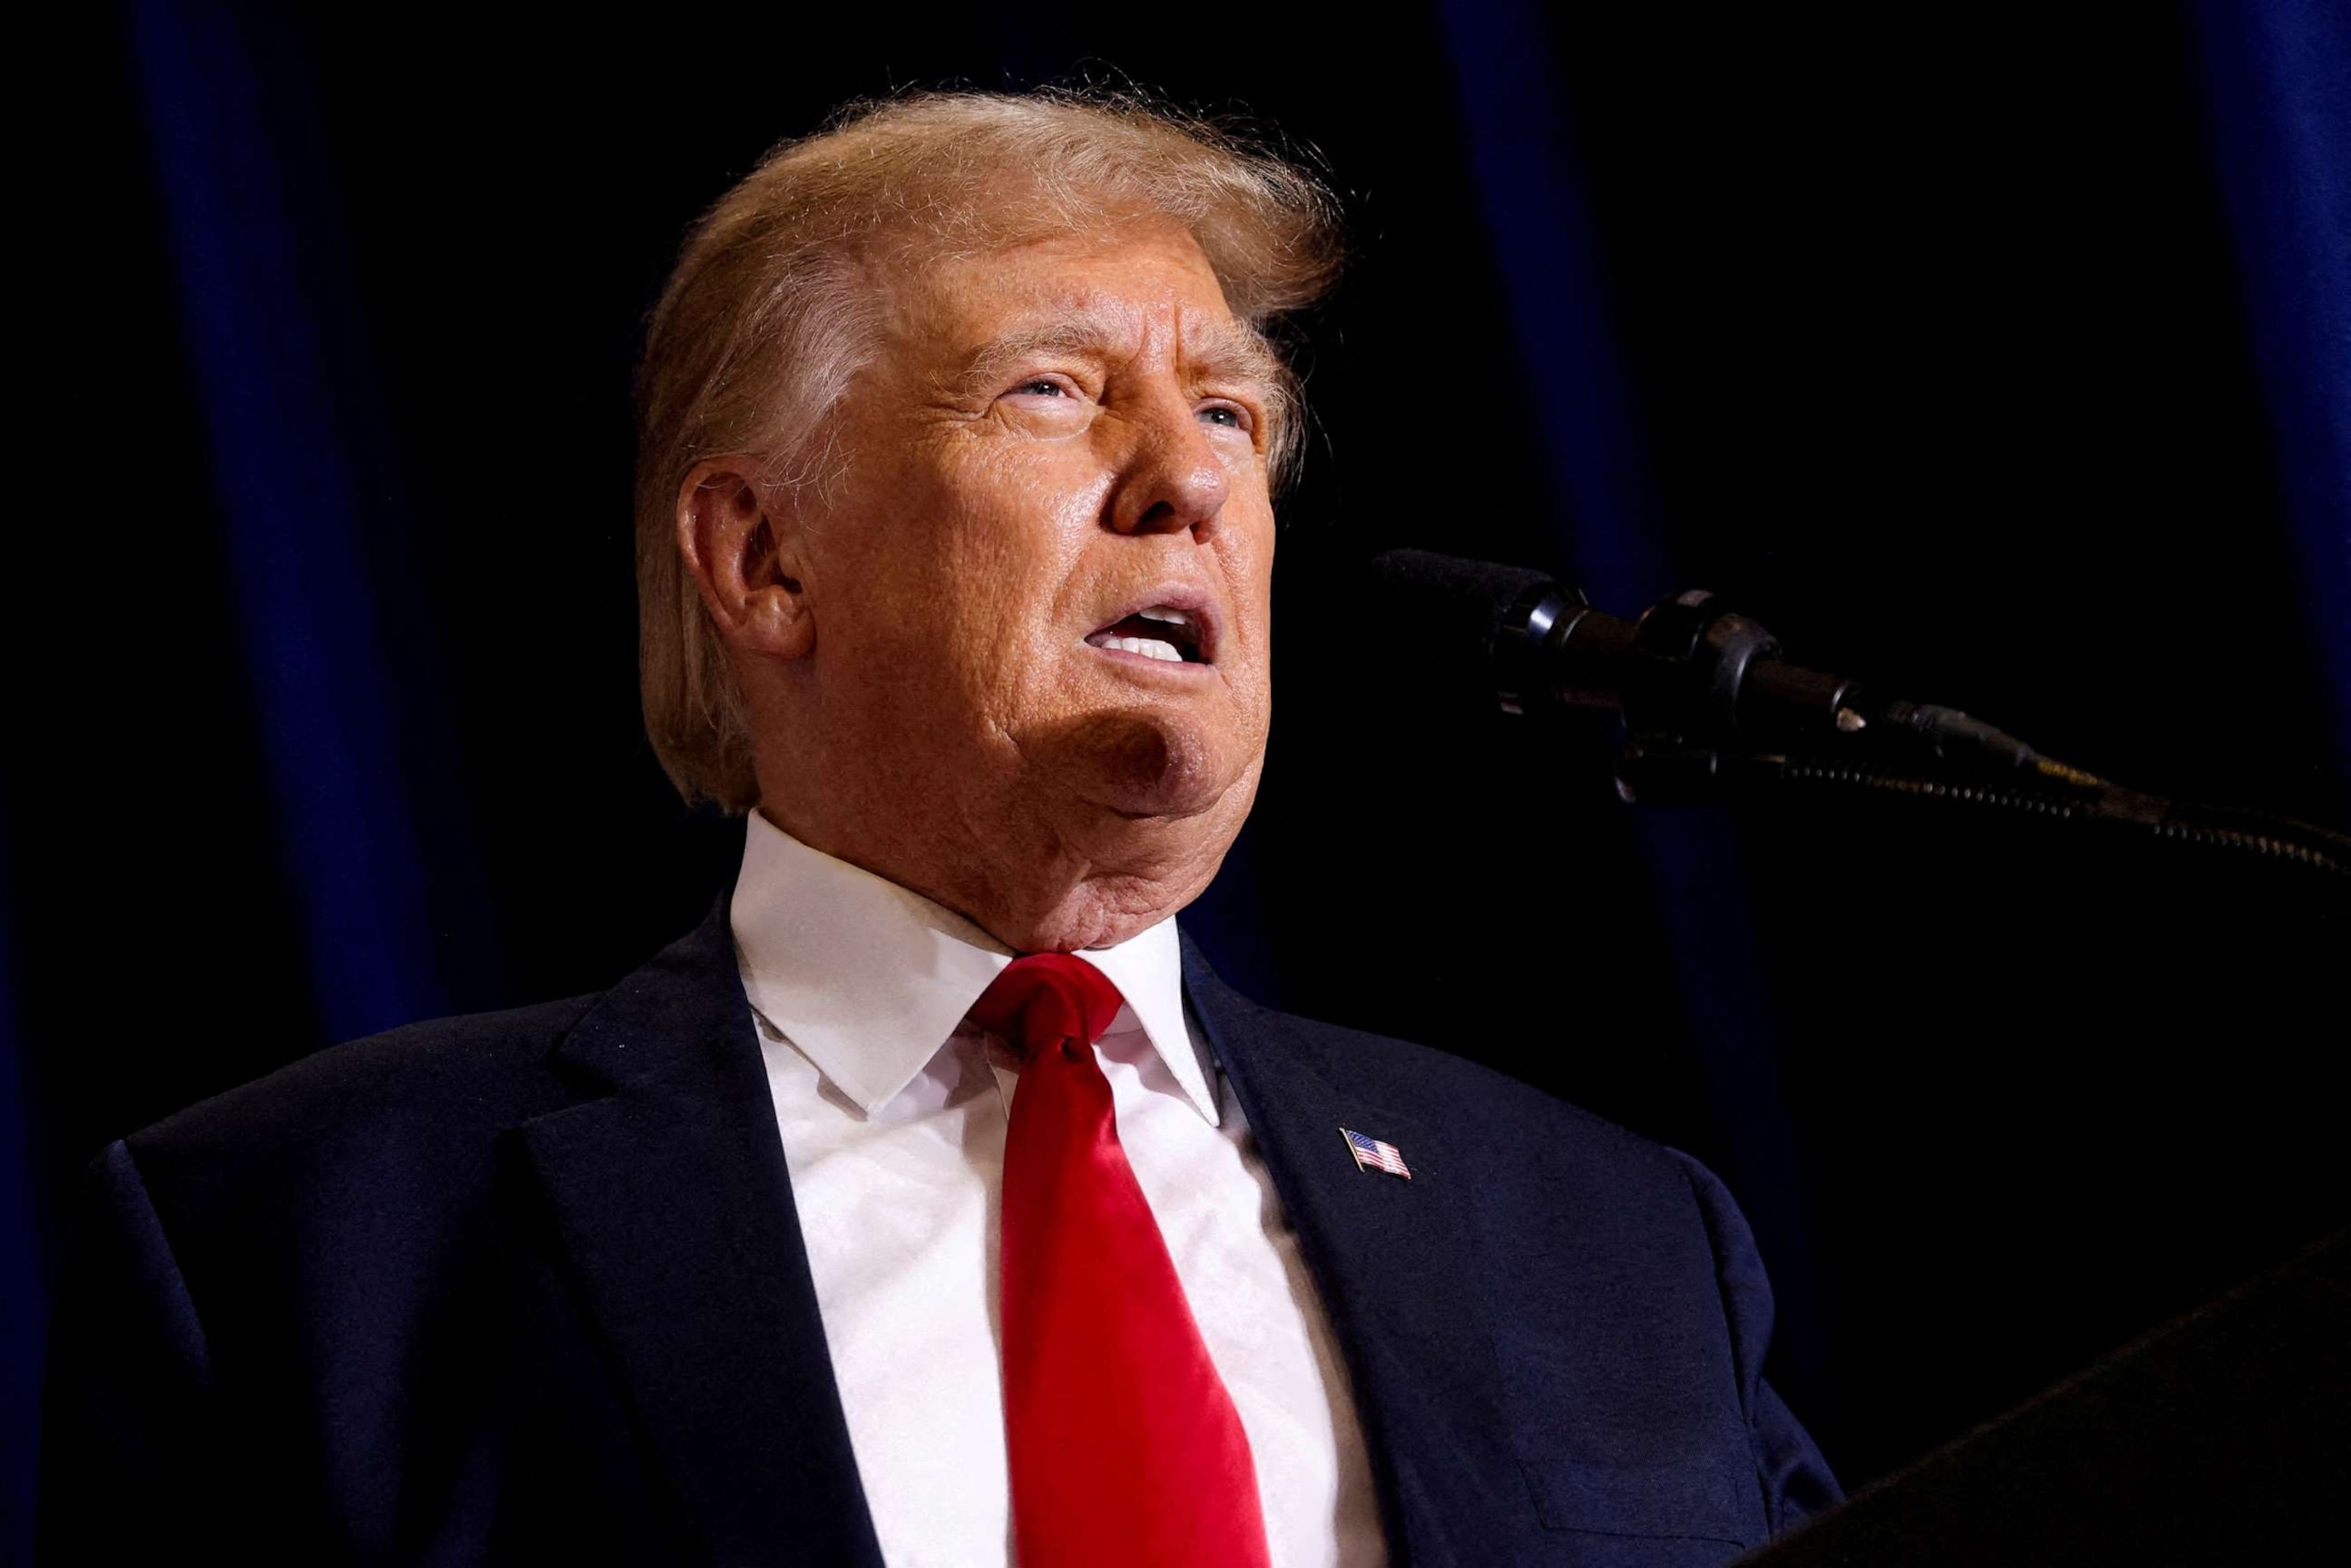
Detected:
left=729, top=811, right=1218, bottom=1126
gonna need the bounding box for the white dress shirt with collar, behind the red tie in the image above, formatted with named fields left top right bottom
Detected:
left=733, top=813, right=1387, bottom=1568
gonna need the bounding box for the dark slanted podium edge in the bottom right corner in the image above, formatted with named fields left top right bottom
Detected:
left=1740, top=1232, right=2351, bottom=1568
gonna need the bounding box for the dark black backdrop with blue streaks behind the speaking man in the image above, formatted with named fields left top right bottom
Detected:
left=0, top=0, right=2351, bottom=1518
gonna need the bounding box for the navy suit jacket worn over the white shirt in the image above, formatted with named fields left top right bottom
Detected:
left=40, top=901, right=1836, bottom=1568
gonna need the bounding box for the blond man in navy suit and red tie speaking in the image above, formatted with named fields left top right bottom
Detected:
left=42, top=94, right=1834, bottom=1568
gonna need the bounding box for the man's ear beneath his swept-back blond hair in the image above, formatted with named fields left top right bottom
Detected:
left=677, top=454, right=816, bottom=658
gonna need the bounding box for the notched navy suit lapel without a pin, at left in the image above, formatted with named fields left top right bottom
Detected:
left=522, top=895, right=882, bottom=1568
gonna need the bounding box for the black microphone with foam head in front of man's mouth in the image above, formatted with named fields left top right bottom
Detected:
left=1371, top=550, right=2049, bottom=781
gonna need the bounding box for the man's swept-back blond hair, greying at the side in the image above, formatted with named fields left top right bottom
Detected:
left=637, top=90, right=1340, bottom=811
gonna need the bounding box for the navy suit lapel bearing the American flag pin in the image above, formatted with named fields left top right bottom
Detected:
left=1185, top=940, right=1533, bottom=1566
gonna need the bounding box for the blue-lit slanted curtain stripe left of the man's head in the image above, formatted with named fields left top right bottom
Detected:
left=127, top=0, right=491, bottom=1044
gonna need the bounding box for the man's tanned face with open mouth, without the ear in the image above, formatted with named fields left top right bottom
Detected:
left=797, top=223, right=1277, bottom=870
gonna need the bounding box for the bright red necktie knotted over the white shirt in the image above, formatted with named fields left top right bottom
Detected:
left=971, top=952, right=1267, bottom=1568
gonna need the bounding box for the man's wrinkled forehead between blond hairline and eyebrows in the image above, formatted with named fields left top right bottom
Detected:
left=889, top=219, right=1255, bottom=367
